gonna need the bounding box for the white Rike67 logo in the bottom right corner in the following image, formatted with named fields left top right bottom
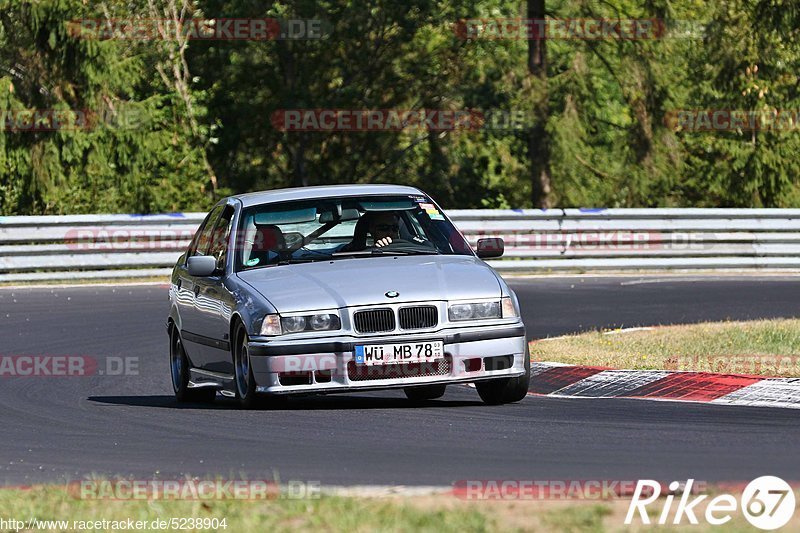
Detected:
left=625, top=476, right=795, bottom=530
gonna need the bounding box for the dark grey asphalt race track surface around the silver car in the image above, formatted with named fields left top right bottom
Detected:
left=0, top=277, right=800, bottom=485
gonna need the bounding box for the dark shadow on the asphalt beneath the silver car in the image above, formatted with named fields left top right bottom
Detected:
left=87, top=395, right=484, bottom=411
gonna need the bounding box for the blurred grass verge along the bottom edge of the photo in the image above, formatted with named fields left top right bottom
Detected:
left=0, top=485, right=800, bottom=533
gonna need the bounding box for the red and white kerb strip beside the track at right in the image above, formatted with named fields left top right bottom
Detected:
left=530, top=362, right=800, bottom=409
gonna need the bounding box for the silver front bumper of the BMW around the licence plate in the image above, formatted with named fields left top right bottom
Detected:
left=248, top=324, right=528, bottom=394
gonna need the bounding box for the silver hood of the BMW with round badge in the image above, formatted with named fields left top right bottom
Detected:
left=238, top=255, right=501, bottom=313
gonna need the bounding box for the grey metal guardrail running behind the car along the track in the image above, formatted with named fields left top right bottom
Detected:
left=0, top=209, right=800, bottom=282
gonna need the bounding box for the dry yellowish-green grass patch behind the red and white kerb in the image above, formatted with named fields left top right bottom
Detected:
left=530, top=319, right=800, bottom=377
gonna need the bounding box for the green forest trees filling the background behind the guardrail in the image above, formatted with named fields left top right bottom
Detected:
left=0, top=0, right=800, bottom=214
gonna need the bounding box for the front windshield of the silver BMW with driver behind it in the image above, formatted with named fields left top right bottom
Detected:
left=236, top=195, right=473, bottom=270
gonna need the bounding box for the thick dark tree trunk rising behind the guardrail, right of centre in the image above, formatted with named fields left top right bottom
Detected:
left=528, top=0, right=550, bottom=209
